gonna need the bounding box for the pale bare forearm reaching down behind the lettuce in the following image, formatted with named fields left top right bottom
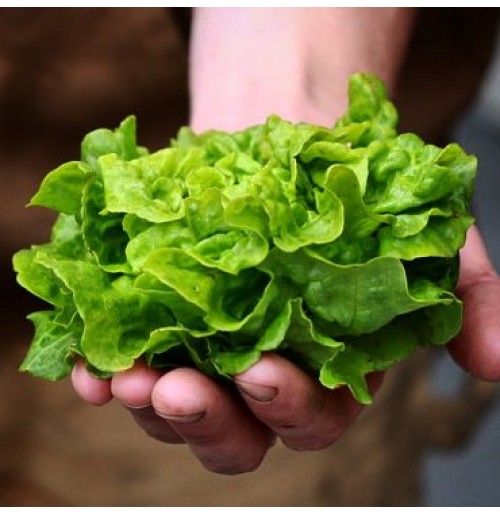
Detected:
left=190, top=8, right=414, bottom=130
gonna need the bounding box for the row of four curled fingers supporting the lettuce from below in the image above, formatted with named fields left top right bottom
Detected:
left=72, top=354, right=381, bottom=474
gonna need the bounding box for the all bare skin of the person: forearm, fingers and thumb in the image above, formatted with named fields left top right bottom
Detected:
left=72, top=8, right=500, bottom=474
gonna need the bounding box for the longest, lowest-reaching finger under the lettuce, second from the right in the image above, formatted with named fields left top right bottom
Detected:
left=152, top=368, right=273, bottom=474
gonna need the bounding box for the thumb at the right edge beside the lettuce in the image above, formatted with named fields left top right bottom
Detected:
left=449, top=227, right=500, bottom=381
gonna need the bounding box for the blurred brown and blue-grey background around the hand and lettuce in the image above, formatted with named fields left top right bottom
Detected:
left=0, top=8, right=500, bottom=506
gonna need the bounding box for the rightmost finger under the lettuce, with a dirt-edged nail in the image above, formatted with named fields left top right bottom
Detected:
left=235, top=354, right=361, bottom=450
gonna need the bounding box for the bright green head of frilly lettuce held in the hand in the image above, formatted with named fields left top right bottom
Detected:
left=13, top=73, right=476, bottom=403
